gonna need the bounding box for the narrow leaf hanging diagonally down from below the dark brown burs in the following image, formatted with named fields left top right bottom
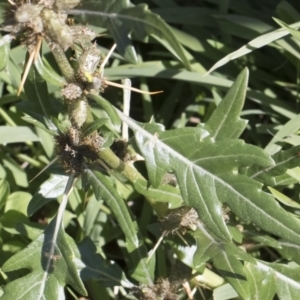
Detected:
left=83, top=169, right=154, bottom=284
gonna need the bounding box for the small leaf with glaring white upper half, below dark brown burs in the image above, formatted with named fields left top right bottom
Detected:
left=27, top=175, right=69, bottom=216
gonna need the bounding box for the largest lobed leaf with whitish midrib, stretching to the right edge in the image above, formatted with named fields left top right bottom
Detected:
left=120, top=80, right=300, bottom=243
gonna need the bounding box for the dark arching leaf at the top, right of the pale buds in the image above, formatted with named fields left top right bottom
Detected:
left=70, top=0, right=190, bottom=69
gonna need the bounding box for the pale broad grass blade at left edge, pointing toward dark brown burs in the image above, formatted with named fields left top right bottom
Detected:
left=0, top=126, right=39, bottom=144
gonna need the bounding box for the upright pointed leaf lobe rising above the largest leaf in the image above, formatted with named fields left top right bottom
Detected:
left=205, top=69, right=249, bottom=140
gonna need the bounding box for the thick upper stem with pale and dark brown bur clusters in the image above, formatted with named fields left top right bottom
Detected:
left=1, top=0, right=113, bottom=176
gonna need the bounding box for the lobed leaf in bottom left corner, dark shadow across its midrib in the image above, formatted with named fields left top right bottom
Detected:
left=1, top=218, right=87, bottom=300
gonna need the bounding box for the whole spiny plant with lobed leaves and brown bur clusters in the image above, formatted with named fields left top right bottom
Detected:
left=0, top=0, right=300, bottom=300
